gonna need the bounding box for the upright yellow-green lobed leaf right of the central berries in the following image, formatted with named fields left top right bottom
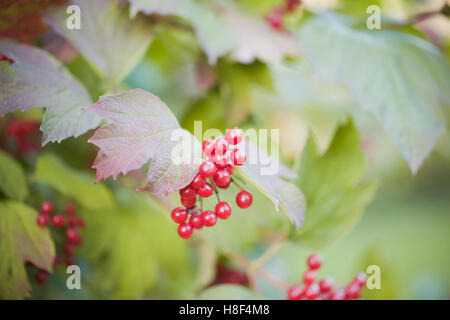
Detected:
left=297, top=123, right=376, bottom=247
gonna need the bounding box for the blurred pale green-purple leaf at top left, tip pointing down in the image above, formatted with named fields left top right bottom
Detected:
left=46, top=0, right=153, bottom=85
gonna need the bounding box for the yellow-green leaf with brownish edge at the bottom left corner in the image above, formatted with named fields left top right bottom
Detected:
left=0, top=201, right=55, bottom=299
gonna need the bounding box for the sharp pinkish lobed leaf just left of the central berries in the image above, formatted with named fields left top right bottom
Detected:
left=87, top=89, right=202, bottom=194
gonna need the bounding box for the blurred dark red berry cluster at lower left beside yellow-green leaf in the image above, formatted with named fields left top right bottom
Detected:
left=36, top=201, right=86, bottom=284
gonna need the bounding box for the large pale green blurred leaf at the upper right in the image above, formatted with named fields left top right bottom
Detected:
left=300, top=15, right=450, bottom=173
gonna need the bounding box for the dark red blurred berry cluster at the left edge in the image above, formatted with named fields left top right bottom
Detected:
left=0, top=119, right=41, bottom=158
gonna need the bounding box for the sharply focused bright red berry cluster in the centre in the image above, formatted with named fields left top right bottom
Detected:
left=172, top=128, right=253, bottom=239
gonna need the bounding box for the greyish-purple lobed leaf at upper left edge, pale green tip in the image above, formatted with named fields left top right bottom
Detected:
left=0, top=39, right=100, bottom=144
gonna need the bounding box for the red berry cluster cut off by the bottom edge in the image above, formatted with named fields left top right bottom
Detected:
left=287, top=254, right=367, bottom=300
